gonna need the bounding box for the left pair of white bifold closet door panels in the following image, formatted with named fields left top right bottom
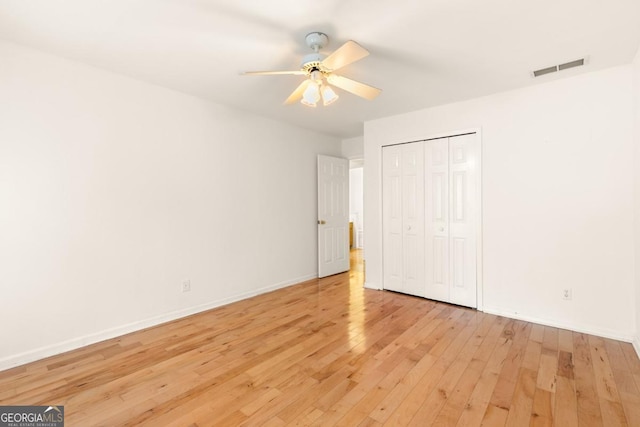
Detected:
left=382, top=142, right=425, bottom=296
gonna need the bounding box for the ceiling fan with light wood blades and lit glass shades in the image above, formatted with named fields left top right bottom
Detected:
left=244, top=32, right=382, bottom=107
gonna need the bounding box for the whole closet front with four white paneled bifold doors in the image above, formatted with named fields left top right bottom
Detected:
left=382, top=133, right=480, bottom=307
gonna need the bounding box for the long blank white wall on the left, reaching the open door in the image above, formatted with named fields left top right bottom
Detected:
left=0, top=42, right=341, bottom=369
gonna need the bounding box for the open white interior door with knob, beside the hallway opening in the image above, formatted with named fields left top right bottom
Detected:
left=318, top=155, right=349, bottom=277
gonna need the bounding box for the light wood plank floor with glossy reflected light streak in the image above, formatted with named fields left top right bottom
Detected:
left=0, top=252, right=640, bottom=427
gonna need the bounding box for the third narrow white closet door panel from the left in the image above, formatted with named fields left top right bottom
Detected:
left=424, top=138, right=450, bottom=301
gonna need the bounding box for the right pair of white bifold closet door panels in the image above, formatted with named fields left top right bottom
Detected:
left=424, top=134, right=479, bottom=307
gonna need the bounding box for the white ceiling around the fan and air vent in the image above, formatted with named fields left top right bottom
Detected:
left=0, top=0, right=640, bottom=138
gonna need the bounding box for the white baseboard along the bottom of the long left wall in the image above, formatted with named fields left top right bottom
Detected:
left=0, top=274, right=318, bottom=371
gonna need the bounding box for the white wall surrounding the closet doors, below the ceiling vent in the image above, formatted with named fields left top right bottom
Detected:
left=364, top=66, right=637, bottom=340
